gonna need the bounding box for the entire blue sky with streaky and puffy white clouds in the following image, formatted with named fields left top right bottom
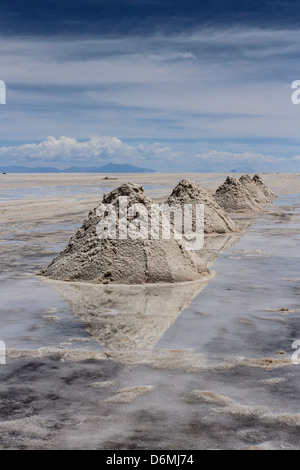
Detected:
left=0, top=0, right=300, bottom=171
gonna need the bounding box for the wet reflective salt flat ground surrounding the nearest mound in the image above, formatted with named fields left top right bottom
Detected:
left=0, top=178, right=300, bottom=450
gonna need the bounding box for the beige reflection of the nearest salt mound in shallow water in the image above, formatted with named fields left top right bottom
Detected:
left=50, top=278, right=208, bottom=350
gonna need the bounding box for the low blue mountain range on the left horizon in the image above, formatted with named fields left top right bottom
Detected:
left=0, top=163, right=155, bottom=173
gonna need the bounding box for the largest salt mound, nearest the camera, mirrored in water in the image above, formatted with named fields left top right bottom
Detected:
left=41, top=183, right=209, bottom=284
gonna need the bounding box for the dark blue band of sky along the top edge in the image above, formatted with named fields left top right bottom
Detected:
left=0, top=0, right=300, bottom=35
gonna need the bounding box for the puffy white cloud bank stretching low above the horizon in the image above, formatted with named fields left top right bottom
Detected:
left=0, top=135, right=290, bottom=171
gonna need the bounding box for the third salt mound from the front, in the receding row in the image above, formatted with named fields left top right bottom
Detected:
left=214, top=176, right=261, bottom=212
